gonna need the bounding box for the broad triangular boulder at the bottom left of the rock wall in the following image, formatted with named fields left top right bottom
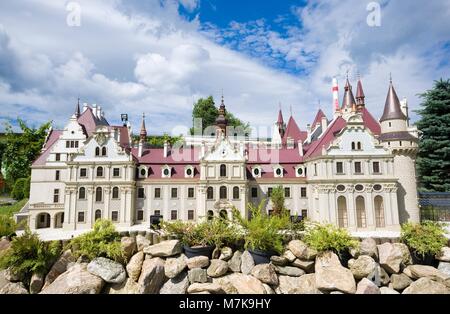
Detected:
left=41, top=263, right=104, bottom=294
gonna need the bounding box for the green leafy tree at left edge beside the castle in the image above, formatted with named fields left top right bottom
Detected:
left=2, top=119, right=50, bottom=186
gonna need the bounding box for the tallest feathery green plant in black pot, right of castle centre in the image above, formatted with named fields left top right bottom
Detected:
left=233, top=200, right=289, bottom=265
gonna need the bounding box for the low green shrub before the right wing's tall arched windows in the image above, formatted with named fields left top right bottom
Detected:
left=303, top=224, right=358, bottom=256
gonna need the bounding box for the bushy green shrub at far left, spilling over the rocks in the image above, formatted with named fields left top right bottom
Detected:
left=0, top=228, right=61, bottom=282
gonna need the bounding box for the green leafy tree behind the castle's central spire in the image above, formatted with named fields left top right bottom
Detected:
left=191, top=96, right=250, bottom=135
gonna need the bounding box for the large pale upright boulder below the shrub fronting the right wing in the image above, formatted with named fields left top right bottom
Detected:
left=315, top=252, right=356, bottom=293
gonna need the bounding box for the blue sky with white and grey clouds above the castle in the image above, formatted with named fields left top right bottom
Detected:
left=0, top=0, right=450, bottom=134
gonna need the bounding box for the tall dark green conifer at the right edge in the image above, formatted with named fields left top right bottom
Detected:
left=417, top=79, right=450, bottom=192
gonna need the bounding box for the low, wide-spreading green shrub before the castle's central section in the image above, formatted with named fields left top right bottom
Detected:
left=161, top=218, right=238, bottom=248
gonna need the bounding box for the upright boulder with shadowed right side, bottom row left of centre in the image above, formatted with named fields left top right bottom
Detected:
left=138, top=257, right=166, bottom=294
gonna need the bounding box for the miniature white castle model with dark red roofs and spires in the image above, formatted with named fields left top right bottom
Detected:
left=22, top=78, right=420, bottom=231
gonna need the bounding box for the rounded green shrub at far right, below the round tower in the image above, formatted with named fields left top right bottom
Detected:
left=400, top=221, right=448, bottom=258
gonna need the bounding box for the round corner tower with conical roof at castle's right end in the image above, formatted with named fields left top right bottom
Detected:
left=379, top=80, right=420, bottom=223
